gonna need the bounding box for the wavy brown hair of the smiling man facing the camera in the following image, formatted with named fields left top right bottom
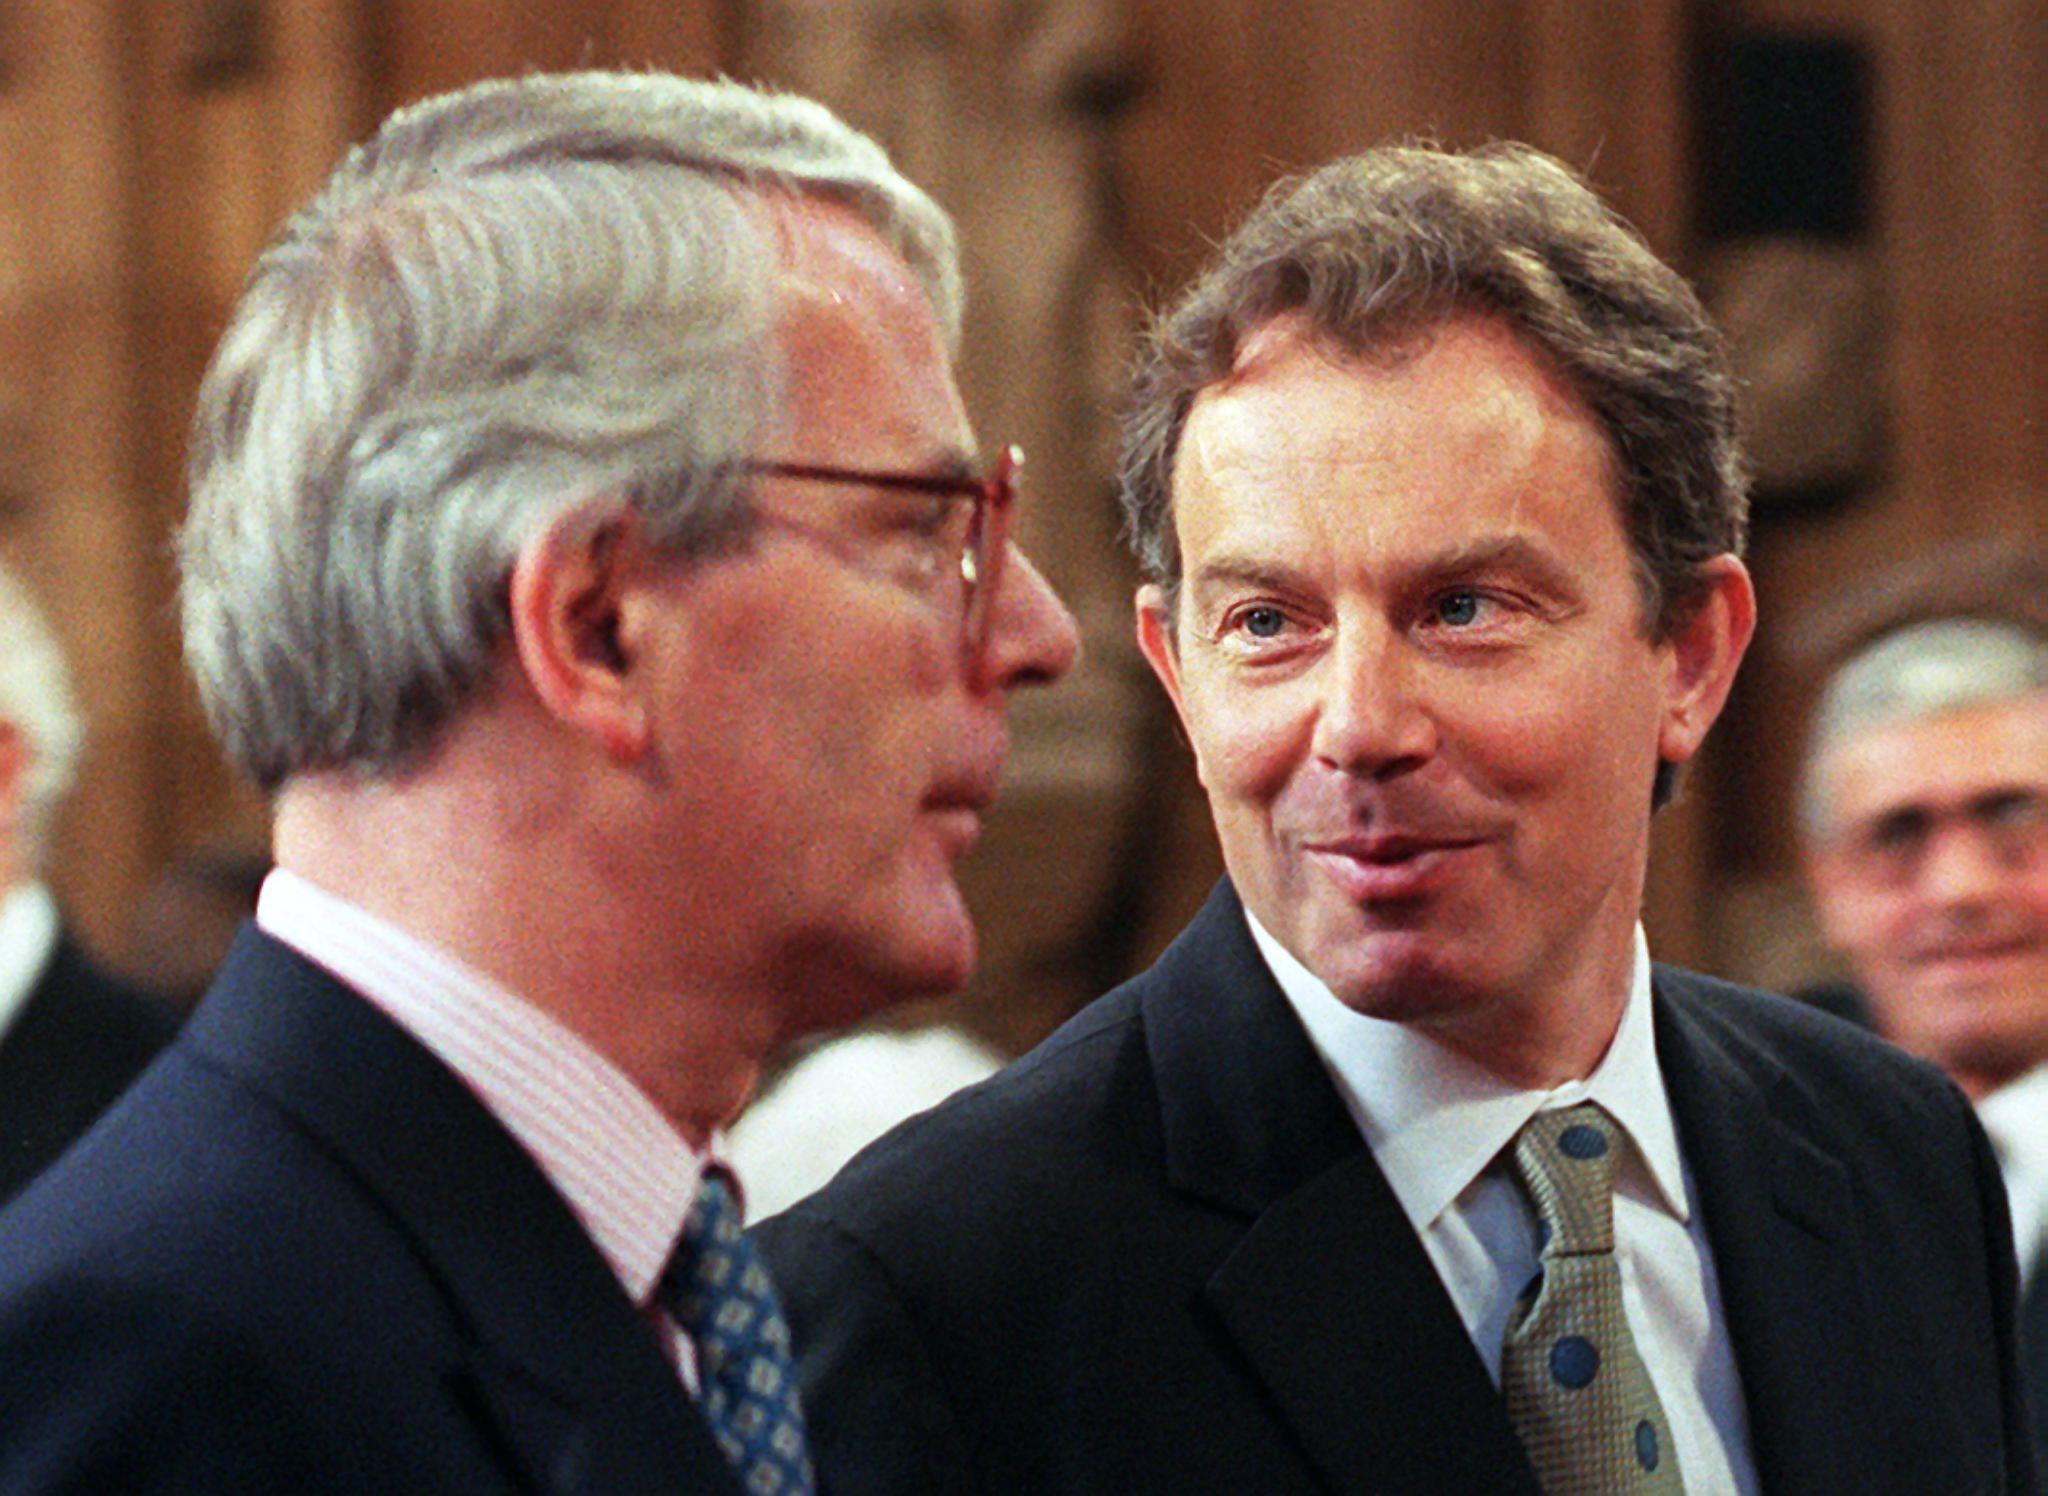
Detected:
left=1120, top=143, right=1749, bottom=637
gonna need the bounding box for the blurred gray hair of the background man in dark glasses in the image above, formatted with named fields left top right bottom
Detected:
left=1798, top=619, right=2048, bottom=838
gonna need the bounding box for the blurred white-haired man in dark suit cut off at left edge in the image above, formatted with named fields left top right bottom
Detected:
left=0, top=568, right=174, bottom=1201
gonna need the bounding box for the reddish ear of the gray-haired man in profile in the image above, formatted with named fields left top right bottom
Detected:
left=510, top=510, right=649, bottom=762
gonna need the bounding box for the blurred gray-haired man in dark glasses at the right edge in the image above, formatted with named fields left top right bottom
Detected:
left=1800, top=547, right=2048, bottom=1450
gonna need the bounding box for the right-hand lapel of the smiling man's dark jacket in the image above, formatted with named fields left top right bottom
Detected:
left=1655, top=967, right=1886, bottom=1490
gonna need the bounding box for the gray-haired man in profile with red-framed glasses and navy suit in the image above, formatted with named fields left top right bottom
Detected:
left=0, top=74, right=1077, bottom=1492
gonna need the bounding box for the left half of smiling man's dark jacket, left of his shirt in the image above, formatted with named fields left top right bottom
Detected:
left=758, top=889, right=1534, bottom=1496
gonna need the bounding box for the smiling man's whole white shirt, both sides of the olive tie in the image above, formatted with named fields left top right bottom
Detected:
left=1245, top=912, right=1757, bottom=1492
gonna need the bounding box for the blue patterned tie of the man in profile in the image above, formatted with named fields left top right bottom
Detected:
left=657, top=1172, right=817, bottom=1496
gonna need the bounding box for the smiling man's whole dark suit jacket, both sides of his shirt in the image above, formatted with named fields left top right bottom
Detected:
left=758, top=885, right=2032, bottom=1496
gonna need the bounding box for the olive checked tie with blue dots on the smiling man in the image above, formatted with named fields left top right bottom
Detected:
left=1501, top=1103, right=1686, bottom=1496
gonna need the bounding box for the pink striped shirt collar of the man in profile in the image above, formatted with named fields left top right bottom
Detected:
left=256, top=869, right=717, bottom=1391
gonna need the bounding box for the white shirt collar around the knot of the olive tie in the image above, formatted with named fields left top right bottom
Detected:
left=1245, top=910, right=1690, bottom=1232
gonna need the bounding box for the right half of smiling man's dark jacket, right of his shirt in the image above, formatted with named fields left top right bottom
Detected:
left=1655, top=967, right=2036, bottom=1492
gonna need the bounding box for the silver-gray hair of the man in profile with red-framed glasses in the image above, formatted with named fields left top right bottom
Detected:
left=180, top=72, right=961, bottom=789
